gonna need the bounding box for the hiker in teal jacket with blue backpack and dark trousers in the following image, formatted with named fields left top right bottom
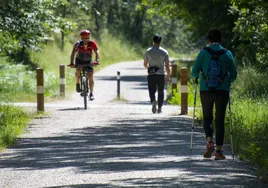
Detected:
left=192, top=28, right=237, bottom=160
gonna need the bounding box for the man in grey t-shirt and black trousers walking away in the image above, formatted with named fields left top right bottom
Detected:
left=143, top=34, right=170, bottom=114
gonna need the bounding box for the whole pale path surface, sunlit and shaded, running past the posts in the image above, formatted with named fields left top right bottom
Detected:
left=0, top=61, right=267, bottom=188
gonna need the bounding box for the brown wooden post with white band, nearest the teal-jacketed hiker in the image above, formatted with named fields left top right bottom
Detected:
left=180, top=67, right=188, bottom=115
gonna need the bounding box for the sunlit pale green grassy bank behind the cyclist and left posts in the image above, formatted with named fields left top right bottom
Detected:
left=0, top=33, right=141, bottom=102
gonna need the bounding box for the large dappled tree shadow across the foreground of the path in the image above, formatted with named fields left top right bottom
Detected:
left=0, top=114, right=262, bottom=188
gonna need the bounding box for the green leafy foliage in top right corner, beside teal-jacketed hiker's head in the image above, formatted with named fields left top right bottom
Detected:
left=230, top=0, right=268, bottom=72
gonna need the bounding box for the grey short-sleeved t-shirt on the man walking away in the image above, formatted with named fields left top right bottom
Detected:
left=144, top=46, right=169, bottom=75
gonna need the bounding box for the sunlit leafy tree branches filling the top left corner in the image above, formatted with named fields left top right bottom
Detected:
left=0, top=0, right=75, bottom=63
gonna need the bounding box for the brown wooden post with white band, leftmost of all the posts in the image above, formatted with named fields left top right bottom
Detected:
left=36, top=68, right=44, bottom=111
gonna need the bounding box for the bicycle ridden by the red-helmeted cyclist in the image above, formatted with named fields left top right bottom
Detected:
left=68, top=62, right=99, bottom=110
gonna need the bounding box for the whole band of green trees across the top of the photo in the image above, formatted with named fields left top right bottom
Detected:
left=0, top=0, right=268, bottom=70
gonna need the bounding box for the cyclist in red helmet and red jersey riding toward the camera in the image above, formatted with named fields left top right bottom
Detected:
left=68, top=30, right=100, bottom=100
